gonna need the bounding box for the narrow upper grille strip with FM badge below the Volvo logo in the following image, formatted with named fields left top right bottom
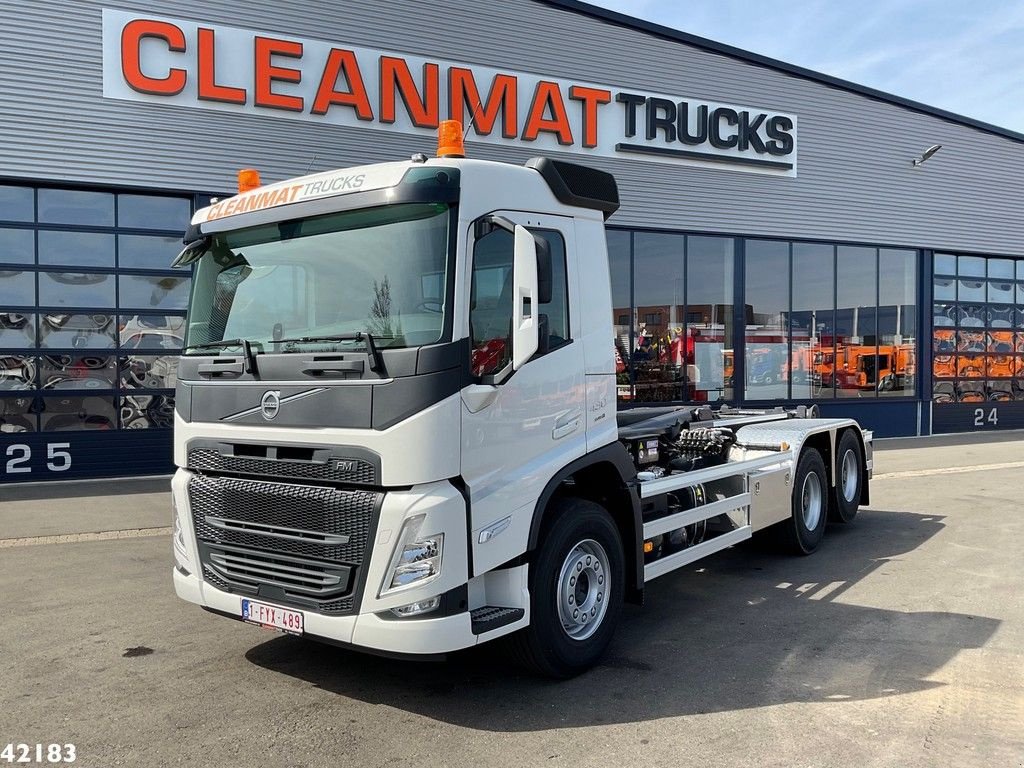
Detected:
left=188, top=449, right=377, bottom=485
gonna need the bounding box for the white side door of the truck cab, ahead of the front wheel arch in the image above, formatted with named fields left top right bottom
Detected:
left=462, top=211, right=587, bottom=573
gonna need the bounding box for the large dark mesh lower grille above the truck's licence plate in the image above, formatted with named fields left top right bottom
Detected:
left=188, top=475, right=383, bottom=614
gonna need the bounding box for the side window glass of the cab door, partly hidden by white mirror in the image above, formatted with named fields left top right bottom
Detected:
left=469, top=228, right=571, bottom=376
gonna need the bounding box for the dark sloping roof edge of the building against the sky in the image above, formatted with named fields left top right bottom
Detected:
left=536, top=0, right=1024, bottom=143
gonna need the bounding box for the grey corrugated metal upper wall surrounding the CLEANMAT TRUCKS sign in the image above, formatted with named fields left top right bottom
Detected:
left=0, top=0, right=1024, bottom=255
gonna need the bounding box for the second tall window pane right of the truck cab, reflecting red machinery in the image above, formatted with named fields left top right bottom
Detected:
left=631, top=232, right=692, bottom=402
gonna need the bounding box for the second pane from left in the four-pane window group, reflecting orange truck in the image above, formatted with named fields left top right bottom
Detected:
left=791, top=243, right=836, bottom=399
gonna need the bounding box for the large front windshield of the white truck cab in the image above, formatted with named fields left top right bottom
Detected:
left=185, top=203, right=451, bottom=354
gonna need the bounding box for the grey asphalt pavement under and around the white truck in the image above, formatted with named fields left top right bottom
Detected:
left=0, top=435, right=1024, bottom=768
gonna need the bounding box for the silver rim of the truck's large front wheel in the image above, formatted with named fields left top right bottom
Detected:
left=557, top=539, right=611, bottom=640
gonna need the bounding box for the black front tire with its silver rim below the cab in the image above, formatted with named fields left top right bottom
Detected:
left=510, top=499, right=626, bottom=679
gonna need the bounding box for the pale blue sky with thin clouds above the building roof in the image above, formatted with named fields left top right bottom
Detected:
left=590, top=0, right=1024, bottom=133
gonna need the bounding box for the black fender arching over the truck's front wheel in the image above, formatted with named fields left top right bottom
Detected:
left=526, top=441, right=643, bottom=602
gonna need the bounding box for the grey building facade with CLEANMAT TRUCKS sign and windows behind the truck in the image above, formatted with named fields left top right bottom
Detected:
left=0, top=0, right=1024, bottom=482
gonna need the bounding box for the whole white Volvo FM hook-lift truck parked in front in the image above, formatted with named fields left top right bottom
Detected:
left=172, top=124, right=871, bottom=677
